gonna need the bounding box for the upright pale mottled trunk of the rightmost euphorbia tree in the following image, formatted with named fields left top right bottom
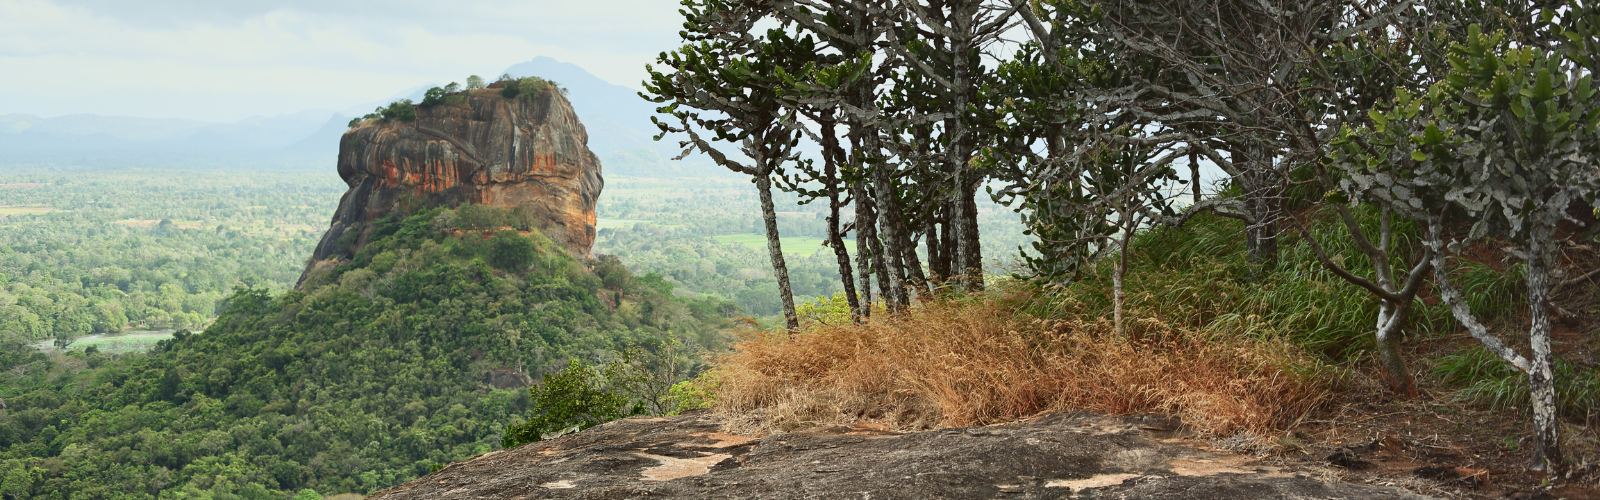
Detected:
left=1528, top=228, right=1563, bottom=473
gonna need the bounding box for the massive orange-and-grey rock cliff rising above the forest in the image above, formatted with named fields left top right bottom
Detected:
left=307, top=88, right=605, bottom=282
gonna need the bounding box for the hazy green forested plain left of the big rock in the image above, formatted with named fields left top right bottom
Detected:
left=0, top=170, right=346, bottom=340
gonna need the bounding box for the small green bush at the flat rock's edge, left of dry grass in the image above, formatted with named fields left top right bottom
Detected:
left=501, top=359, right=645, bottom=449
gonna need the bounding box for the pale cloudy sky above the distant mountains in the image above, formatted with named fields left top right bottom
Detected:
left=0, top=0, right=682, bottom=122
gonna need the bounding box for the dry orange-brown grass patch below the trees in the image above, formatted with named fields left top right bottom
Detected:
left=712, top=284, right=1334, bottom=436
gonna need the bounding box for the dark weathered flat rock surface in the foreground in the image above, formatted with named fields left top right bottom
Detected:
left=371, top=413, right=1424, bottom=500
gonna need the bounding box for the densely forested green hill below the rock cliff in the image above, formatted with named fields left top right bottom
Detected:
left=0, top=207, right=736, bottom=498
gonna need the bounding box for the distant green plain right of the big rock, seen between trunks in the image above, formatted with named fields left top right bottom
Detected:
left=595, top=178, right=1030, bottom=314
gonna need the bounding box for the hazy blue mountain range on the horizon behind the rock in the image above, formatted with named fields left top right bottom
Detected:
left=0, top=56, right=720, bottom=176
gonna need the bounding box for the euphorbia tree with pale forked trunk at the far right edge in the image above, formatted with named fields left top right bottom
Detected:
left=1338, top=26, right=1600, bottom=470
